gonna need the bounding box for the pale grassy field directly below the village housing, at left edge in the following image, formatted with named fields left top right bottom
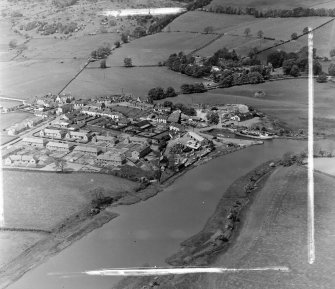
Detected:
left=3, top=171, right=138, bottom=229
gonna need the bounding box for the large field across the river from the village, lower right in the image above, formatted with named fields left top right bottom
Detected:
left=198, top=167, right=335, bottom=288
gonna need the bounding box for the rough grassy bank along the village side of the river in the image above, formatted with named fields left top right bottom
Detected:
left=0, top=138, right=258, bottom=288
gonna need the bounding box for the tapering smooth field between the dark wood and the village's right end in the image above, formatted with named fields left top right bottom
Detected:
left=161, top=79, right=335, bottom=134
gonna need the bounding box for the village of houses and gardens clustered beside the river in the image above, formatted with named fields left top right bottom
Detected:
left=2, top=94, right=274, bottom=182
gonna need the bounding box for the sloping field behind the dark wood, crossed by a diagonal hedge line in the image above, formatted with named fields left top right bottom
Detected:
left=198, top=13, right=335, bottom=57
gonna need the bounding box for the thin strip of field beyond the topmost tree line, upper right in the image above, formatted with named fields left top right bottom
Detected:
left=208, top=0, right=335, bottom=9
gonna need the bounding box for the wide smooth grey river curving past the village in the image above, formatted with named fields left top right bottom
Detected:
left=9, top=140, right=307, bottom=289
